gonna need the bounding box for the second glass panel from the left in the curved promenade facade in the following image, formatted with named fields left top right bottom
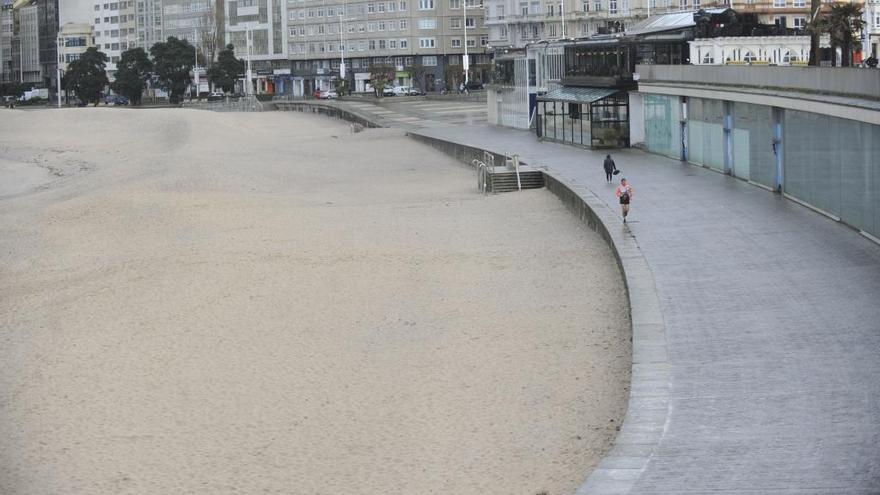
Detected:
left=687, top=98, right=725, bottom=171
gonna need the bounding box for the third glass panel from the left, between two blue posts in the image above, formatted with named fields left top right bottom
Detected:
left=733, top=102, right=776, bottom=189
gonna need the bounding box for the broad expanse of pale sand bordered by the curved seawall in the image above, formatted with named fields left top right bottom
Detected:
left=0, top=108, right=631, bottom=495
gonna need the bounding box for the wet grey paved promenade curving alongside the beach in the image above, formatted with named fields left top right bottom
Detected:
left=298, top=99, right=880, bottom=494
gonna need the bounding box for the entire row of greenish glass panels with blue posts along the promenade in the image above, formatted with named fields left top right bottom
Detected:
left=644, top=94, right=880, bottom=241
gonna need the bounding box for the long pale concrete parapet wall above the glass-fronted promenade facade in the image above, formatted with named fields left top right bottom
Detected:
left=636, top=65, right=880, bottom=100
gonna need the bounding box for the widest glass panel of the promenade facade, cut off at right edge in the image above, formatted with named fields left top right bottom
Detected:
left=783, top=110, right=880, bottom=237
